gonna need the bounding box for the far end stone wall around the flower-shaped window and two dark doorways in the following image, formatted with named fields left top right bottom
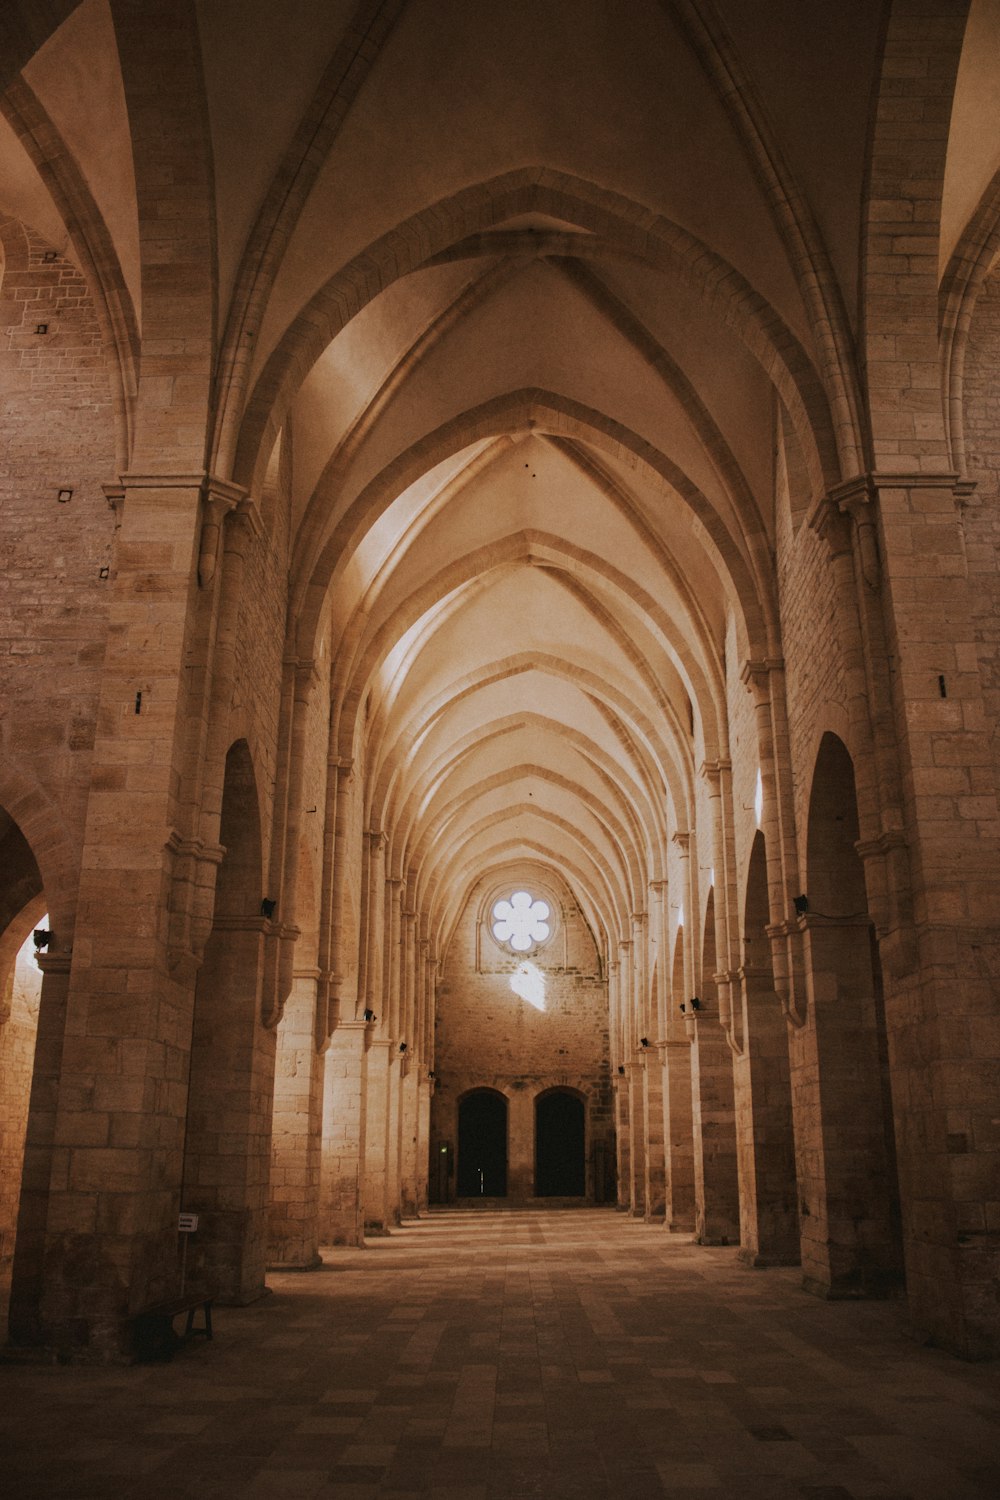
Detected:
left=430, top=870, right=615, bottom=1202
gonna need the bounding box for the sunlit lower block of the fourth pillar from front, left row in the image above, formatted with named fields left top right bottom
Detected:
left=319, top=1020, right=367, bottom=1245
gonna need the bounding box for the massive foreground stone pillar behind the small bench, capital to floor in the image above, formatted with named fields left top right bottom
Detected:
left=31, top=474, right=244, bottom=1359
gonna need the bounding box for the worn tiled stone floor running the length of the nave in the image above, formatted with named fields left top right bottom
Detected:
left=0, top=1209, right=1000, bottom=1500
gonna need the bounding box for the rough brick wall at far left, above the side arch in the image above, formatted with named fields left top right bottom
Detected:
left=0, top=219, right=117, bottom=888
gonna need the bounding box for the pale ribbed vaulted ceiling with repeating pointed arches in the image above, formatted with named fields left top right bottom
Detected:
left=0, top=0, right=1000, bottom=960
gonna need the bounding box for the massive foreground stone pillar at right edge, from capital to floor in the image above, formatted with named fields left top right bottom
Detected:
left=817, top=474, right=1000, bottom=1358
